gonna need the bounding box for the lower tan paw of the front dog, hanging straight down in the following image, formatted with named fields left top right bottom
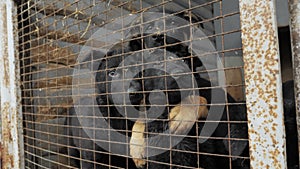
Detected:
left=129, top=120, right=146, bottom=167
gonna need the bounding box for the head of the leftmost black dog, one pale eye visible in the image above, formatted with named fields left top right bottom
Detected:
left=96, top=50, right=141, bottom=105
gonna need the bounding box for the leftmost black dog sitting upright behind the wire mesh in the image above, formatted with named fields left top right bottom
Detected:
left=68, top=50, right=140, bottom=169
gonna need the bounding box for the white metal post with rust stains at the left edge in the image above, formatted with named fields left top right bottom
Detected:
left=0, top=0, right=24, bottom=168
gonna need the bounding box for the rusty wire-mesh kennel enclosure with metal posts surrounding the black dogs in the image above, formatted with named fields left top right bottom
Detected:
left=0, top=0, right=300, bottom=168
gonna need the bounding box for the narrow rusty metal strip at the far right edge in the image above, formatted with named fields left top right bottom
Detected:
left=289, top=0, right=300, bottom=165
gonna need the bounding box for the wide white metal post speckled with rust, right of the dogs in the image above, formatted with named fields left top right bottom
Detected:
left=239, top=0, right=287, bottom=169
